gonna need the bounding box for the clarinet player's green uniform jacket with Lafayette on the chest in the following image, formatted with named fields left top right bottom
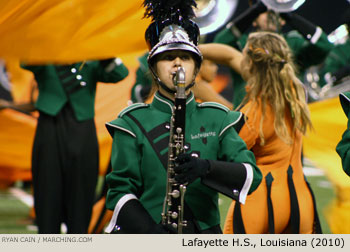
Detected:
left=106, top=93, right=261, bottom=229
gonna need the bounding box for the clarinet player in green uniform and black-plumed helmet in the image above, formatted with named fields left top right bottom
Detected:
left=105, top=0, right=261, bottom=233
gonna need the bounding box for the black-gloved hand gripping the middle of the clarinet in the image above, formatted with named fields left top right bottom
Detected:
left=174, top=153, right=210, bottom=184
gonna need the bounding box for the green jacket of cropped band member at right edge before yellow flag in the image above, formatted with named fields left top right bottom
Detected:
left=336, top=92, right=350, bottom=176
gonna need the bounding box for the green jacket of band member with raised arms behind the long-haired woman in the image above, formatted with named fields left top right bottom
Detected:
left=214, top=28, right=333, bottom=108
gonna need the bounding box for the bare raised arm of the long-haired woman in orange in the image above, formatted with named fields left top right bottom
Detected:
left=198, top=43, right=243, bottom=74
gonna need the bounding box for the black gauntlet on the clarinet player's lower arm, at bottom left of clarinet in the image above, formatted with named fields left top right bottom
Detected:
left=114, top=199, right=176, bottom=234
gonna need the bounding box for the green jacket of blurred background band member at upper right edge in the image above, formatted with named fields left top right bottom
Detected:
left=319, top=39, right=350, bottom=86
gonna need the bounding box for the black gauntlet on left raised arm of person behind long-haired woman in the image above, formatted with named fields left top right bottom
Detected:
left=232, top=0, right=267, bottom=33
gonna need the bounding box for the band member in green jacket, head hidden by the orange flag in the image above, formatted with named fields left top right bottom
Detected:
left=23, top=58, right=128, bottom=233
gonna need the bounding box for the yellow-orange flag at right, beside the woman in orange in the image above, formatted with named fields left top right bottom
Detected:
left=304, top=97, right=350, bottom=234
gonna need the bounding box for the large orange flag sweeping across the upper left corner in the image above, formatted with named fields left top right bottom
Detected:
left=0, top=0, right=150, bottom=64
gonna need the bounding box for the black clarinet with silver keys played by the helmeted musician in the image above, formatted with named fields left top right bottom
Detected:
left=162, top=67, right=187, bottom=234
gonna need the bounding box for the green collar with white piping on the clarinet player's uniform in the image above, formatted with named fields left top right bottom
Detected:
left=152, top=92, right=196, bottom=114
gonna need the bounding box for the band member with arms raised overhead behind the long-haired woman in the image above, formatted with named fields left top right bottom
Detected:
left=214, top=0, right=332, bottom=108
